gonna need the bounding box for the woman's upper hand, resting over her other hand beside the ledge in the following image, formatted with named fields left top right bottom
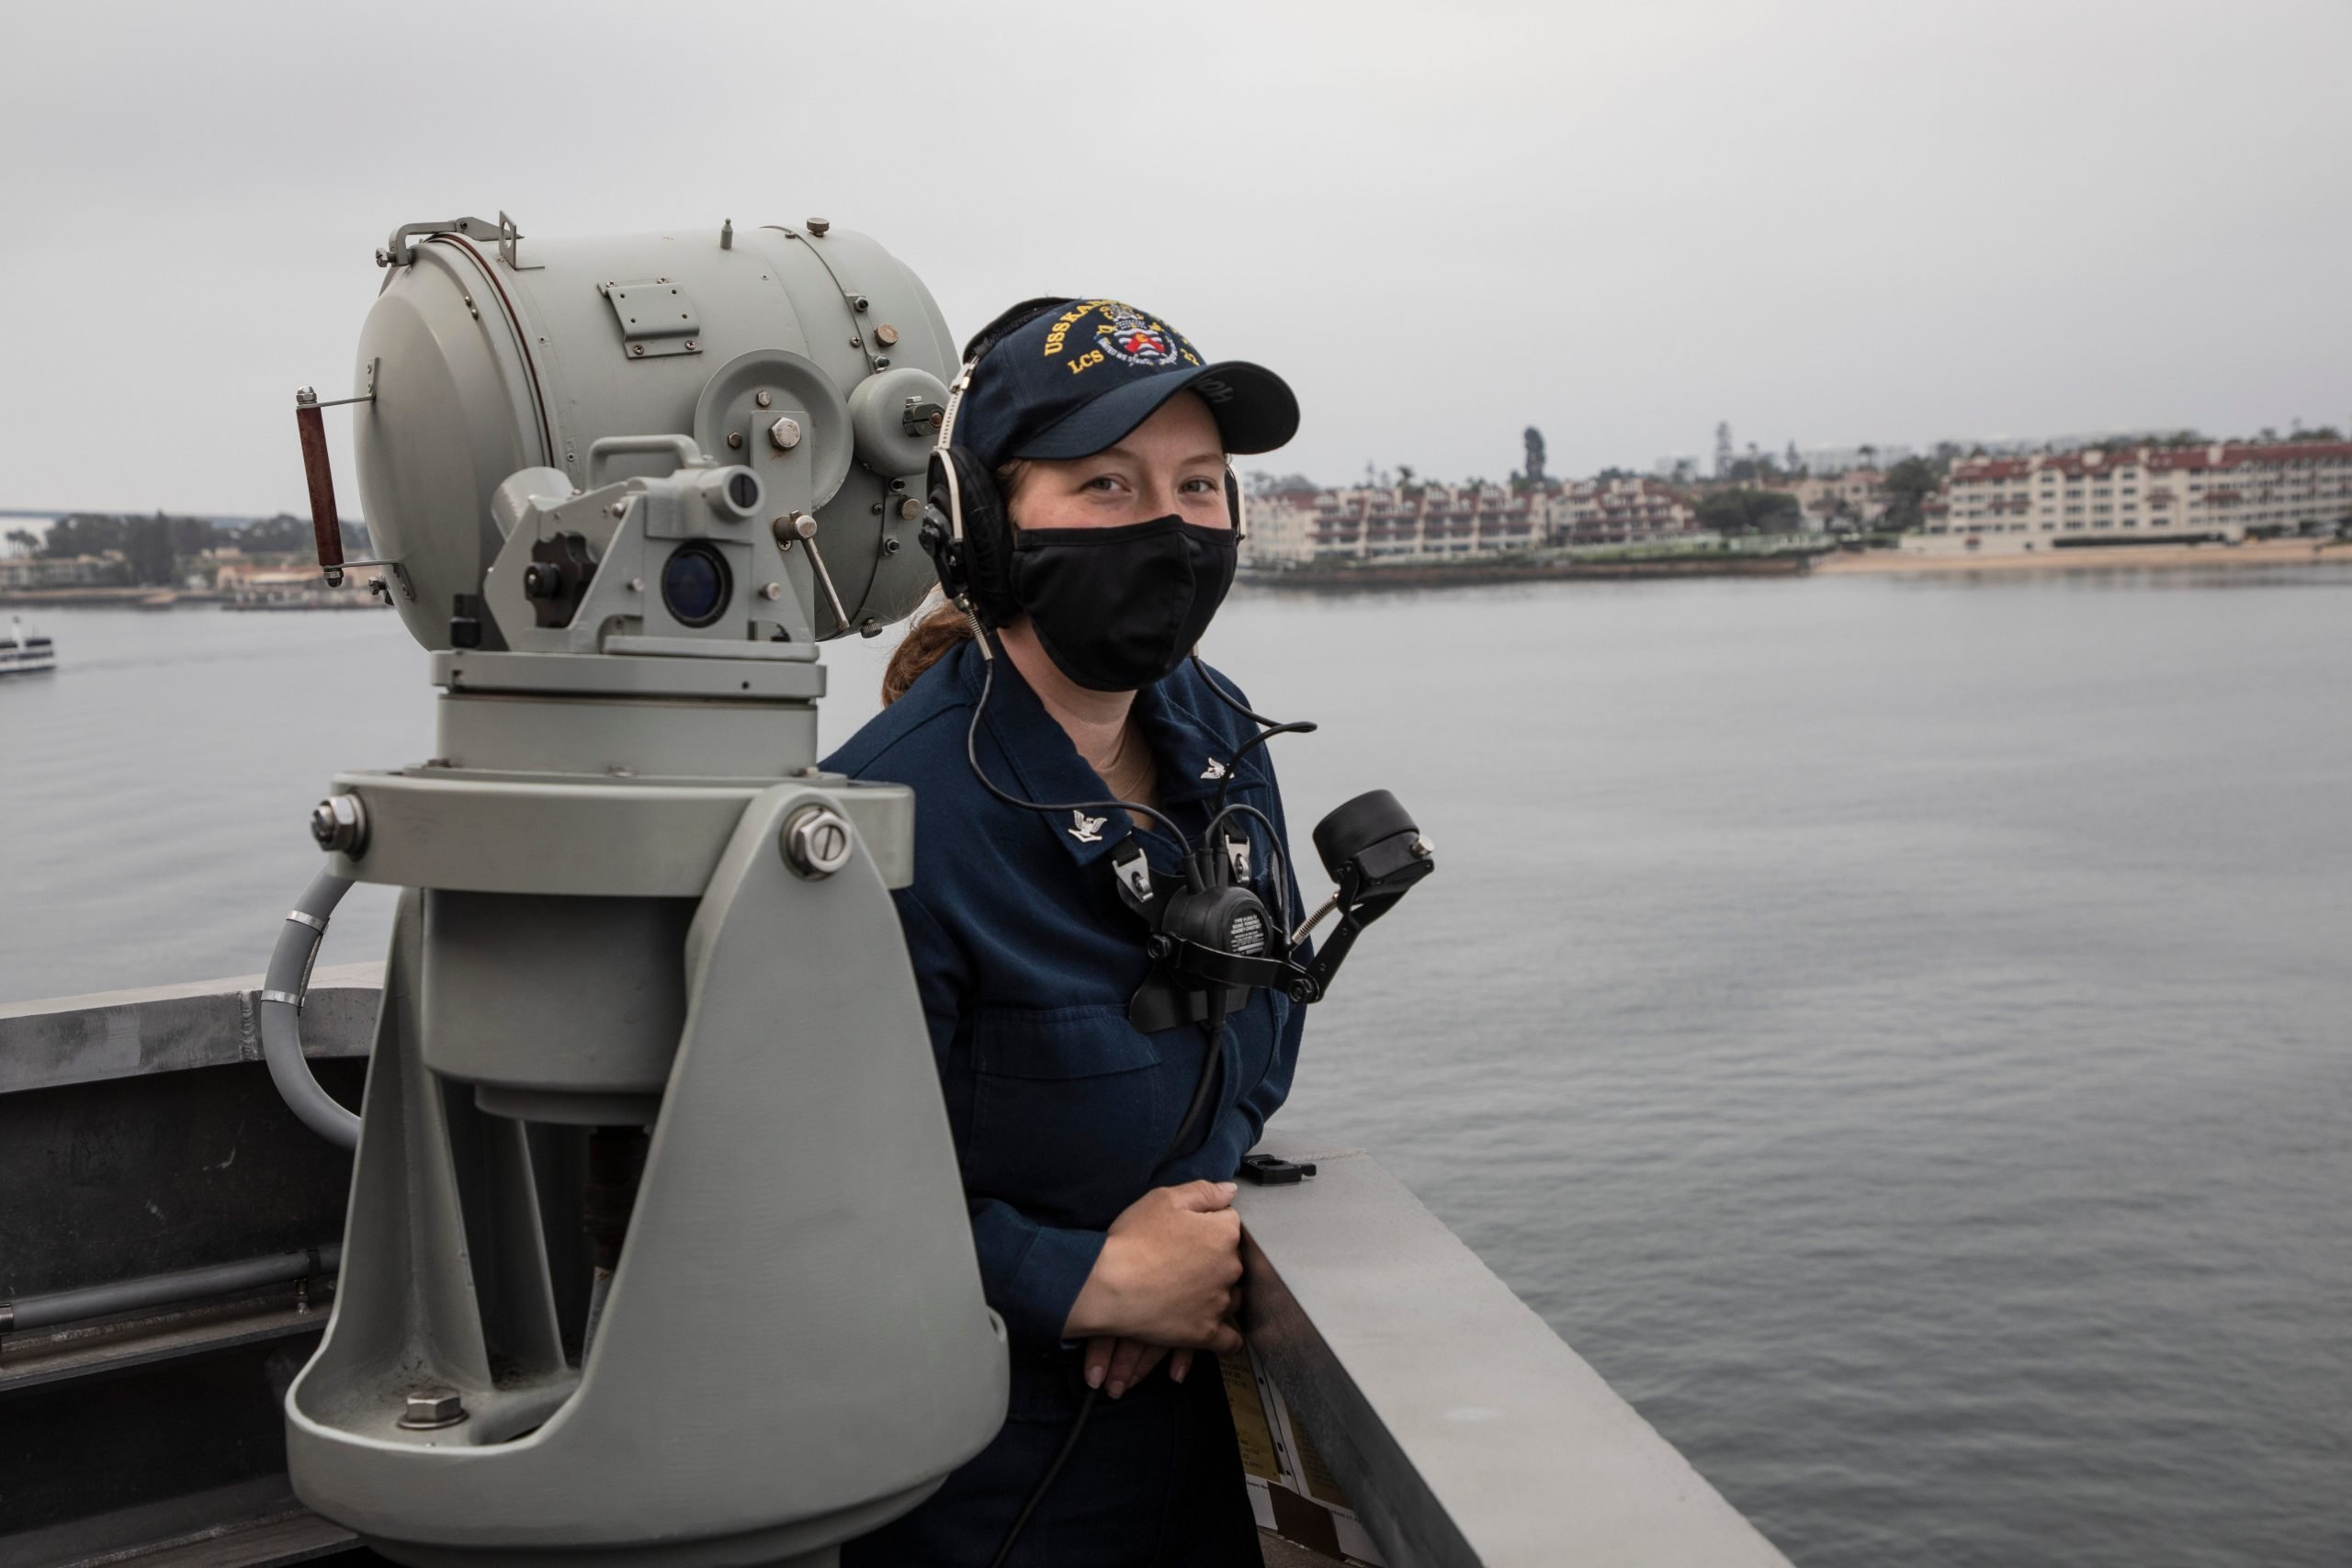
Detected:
left=1063, top=1182, right=1242, bottom=1352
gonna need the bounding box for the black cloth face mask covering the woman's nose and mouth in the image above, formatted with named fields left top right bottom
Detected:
left=1012, top=514, right=1235, bottom=691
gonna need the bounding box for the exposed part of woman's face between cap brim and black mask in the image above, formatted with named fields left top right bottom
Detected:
left=1007, top=392, right=1232, bottom=529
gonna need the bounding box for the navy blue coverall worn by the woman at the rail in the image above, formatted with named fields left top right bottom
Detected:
left=826, top=642, right=1306, bottom=1568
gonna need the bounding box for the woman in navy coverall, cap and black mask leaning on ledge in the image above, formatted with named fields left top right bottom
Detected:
left=826, top=301, right=1301, bottom=1568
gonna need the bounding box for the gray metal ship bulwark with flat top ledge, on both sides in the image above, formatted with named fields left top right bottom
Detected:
left=0, top=964, right=1785, bottom=1568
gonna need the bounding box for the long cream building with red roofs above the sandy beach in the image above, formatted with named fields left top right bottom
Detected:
left=1903, top=442, right=2352, bottom=552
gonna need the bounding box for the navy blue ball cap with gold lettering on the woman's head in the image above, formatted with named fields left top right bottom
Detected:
left=955, top=299, right=1298, bottom=468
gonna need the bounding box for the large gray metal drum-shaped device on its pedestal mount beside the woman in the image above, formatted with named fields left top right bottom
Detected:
left=273, top=214, right=1007, bottom=1568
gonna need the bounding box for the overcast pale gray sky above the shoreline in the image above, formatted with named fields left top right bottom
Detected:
left=0, top=0, right=2352, bottom=514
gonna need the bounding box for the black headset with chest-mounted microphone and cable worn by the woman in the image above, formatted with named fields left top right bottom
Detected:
left=917, top=296, right=1435, bottom=1568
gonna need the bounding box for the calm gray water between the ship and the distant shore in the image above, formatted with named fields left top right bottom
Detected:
left=0, top=581, right=2352, bottom=1568
